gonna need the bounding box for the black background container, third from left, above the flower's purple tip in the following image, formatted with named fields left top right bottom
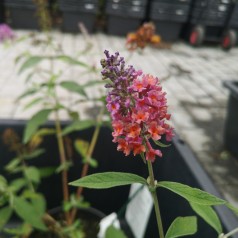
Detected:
left=106, top=0, right=147, bottom=36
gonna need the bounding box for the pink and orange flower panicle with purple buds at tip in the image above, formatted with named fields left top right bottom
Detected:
left=101, top=51, right=174, bottom=162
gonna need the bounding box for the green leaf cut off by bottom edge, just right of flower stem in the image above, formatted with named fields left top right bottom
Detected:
left=165, top=216, right=197, bottom=238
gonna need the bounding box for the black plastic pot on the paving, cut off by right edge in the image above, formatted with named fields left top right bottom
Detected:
left=224, top=81, right=238, bottom=159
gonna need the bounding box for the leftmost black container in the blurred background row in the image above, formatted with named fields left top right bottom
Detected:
left=5, top=0, right=39, bottom=30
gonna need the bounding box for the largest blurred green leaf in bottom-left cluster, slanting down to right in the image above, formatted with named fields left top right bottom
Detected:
left=14, top=197, right=46, bottom=230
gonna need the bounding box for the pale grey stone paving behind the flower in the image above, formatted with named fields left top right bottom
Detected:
left=0, top=31, right=238, bottom=208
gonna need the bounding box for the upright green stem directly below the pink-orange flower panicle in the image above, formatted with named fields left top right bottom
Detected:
left=147, top=161, right=164, bottom=238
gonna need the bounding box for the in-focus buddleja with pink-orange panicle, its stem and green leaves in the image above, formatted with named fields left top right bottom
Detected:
left=70, top=51, right=237, bottom=238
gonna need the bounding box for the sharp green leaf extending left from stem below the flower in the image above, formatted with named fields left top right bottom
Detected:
left=69, top=172, right=147, bottom=189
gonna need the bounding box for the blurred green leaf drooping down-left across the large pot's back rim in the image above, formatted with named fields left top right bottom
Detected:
left=23, top=109, right=52, bottom=144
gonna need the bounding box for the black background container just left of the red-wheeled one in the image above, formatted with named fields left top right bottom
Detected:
left=149, top=0, right=191, bottom=41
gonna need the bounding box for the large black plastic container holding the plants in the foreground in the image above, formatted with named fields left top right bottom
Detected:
left=0, top=121, right=238, bottom=238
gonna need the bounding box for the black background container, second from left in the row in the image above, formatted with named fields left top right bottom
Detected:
left=60, top=0, right=99, bottom=33
